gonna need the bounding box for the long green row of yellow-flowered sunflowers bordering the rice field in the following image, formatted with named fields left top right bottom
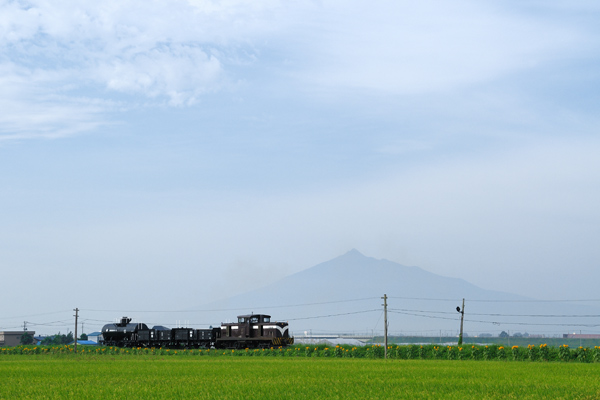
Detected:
left=0, top=344, right=600, bottom=363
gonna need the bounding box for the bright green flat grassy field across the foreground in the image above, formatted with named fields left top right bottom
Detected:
left=0, top=355, right=600, bottom=399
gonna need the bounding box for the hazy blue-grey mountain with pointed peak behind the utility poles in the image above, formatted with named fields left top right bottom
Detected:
left=198, top=250, right=599, bottom=336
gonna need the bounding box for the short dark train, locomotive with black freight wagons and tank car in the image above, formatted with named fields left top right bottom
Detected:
left=101, top=314, right=294, bottom=349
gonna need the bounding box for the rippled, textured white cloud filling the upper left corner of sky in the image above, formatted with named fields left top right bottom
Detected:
left=0, top=0, right=255, bottom=139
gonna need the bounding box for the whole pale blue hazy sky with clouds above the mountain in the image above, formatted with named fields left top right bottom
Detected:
left=0, top=0, right=600, bottom=327
